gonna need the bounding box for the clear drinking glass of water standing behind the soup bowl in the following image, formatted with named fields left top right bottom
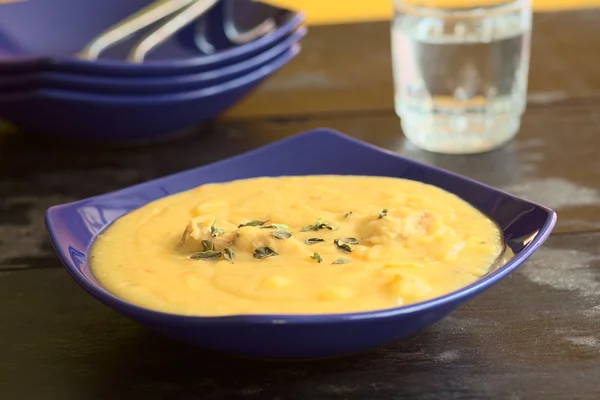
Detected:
left=391, top=0, right=532, bottom=154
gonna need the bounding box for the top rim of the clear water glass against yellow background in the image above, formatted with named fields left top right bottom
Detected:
left=394, top=0, right=531, bottom=18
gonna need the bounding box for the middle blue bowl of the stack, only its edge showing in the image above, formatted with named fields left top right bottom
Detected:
left=0, top=26, right=306, bottom=95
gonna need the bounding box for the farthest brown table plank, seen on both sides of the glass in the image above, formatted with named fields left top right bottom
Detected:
left=227, top=10, right=600, bottom=117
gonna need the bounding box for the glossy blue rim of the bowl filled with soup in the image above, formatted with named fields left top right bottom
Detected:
left=45, top=128, right=557, bottom=325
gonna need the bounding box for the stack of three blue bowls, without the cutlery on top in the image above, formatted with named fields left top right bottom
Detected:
left=0, top=0, right=306, bottom=142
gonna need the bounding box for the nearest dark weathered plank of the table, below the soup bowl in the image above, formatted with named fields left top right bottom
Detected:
left=0, top=234, right=600, bottom=400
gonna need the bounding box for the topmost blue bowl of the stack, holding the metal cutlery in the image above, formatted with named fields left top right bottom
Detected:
left=0, top=0, right=304, bottom=76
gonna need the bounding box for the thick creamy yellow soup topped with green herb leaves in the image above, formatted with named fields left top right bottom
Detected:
left=91, top=176, right=503, bottom=316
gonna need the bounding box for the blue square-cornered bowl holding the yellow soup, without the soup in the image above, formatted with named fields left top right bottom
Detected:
left=46, top=129, right=556, bottom=358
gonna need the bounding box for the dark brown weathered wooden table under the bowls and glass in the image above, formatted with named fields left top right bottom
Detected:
left=0, top=11, right=600, bottom=400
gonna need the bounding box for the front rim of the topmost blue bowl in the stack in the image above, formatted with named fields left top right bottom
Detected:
left=0, top=8, right=305, bottom=73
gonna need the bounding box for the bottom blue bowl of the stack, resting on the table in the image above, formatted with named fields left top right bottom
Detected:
left=0, top=43, right=300, bottom=143
